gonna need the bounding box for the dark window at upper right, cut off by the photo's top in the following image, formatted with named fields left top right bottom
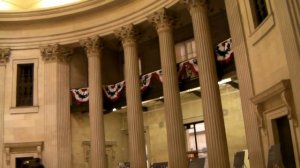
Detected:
left=252, top=0, right=268, bottom=26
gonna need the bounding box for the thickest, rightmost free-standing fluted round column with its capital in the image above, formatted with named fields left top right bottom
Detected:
left=182, top=0, right=230, bottom=168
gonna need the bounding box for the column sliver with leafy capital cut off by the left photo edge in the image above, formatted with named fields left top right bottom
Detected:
left=0, top=48, right=10, bottom=167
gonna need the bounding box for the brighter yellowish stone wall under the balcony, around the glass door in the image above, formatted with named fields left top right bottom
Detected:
left=144, top=85, right=247, bottom=165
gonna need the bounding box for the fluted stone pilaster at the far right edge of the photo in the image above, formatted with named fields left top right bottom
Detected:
left=274, top=0, right=300, bottom=150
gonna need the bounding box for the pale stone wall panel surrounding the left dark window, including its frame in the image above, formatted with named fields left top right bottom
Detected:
left=4, top=49, right=44, bottom=143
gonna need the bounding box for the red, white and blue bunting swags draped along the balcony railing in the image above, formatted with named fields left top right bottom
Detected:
left=71, top=38, right=233, bottom=104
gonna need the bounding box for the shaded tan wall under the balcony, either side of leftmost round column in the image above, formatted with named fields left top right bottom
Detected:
left=71, top=112, right=128, bottom=168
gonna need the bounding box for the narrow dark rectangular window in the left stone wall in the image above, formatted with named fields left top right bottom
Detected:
left=16, top=64, right=33, bottom=106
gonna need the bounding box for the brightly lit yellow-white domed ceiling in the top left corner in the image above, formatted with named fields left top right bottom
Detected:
left=0, top=0, right=87, bottom=12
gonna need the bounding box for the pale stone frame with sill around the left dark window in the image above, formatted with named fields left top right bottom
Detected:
left=10, top=59, right=38, bottom=113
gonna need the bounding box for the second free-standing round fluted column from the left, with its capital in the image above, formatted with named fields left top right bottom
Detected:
left=115, top=25, right=147, bottom=168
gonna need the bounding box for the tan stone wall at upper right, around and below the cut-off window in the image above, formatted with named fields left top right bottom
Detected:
left=240, top=0, right=289, bottom=94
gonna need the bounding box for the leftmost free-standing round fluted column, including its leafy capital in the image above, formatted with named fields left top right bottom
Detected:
left=80, top=36, right=107, bottom=168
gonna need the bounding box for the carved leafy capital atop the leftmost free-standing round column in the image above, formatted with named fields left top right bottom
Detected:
left=79, top=36, right=103, bottom=57
